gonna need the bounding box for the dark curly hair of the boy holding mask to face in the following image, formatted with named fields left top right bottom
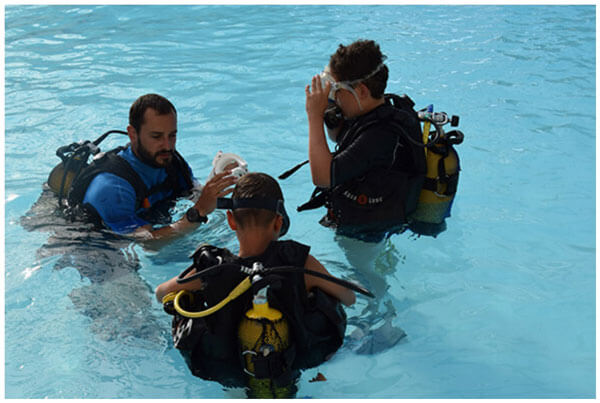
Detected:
left=329, top=40, right=389, bottom=98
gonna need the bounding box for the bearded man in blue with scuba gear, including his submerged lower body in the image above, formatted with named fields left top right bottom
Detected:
left=21, top=94, right=241, bottom=343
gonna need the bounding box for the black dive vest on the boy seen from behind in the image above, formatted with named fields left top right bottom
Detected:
left=172, top=241, right=346, bottom=387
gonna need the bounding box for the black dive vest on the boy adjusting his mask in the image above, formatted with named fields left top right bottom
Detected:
left=298, top=94, right=427, bottom=240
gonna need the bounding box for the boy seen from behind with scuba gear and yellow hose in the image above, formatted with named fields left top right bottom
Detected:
left=156, top=173, right=372, bottom=398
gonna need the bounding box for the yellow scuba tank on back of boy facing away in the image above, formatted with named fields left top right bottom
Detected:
left=238, top=287, right=294, bottom=398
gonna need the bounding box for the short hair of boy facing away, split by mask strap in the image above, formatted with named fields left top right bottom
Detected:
left=231, top=172, right=283, bottom=228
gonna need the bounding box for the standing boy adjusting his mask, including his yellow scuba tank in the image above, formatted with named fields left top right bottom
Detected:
left=296, top=40, right=463, bottom=243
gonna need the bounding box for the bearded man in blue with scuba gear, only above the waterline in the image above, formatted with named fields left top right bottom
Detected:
left=48, top=94, right=237, bottom=247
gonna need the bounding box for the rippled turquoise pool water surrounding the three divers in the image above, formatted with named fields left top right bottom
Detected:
left=4, top=6, right=596, bottom=398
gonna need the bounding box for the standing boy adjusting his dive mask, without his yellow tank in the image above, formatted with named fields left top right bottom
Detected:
left=301, top=40, right=425, bottom=242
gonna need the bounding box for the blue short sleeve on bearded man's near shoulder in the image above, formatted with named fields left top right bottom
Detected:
left=83, top=173, right=148, bottom=234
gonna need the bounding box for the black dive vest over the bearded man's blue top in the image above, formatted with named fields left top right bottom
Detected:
left=68, top=147, right=193, bottom=224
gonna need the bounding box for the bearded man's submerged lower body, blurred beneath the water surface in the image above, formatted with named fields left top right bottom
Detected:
left=21, top=188, right=169, bottom=346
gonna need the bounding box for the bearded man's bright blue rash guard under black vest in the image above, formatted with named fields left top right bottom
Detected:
left=83, top=147, right=193, bottom=234
